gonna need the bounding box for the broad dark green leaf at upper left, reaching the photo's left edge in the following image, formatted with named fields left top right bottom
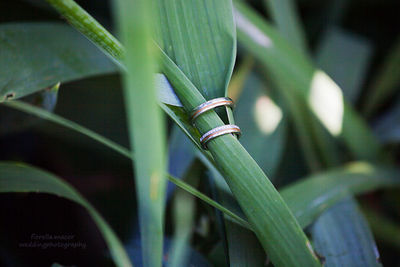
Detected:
left=0, top=22, right=117, bottom=102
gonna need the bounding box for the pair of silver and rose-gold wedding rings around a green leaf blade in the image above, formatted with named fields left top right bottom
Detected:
left=190, top=97, right=241, bottom=149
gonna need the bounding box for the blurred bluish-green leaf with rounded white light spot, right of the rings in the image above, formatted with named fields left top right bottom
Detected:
left=234, top=74, right=287, bottom=177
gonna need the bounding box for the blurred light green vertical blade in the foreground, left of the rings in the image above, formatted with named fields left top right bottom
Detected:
left=116, top=0, right=167, bottom=267
